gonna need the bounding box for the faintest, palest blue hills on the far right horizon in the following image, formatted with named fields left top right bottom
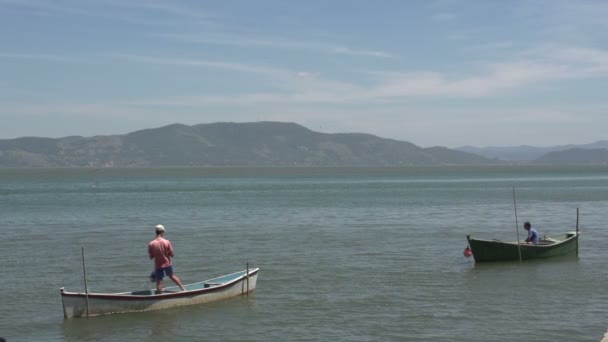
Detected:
left=455, top=140, right=608, bottom=162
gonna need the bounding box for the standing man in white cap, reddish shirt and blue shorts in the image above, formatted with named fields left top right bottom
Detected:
left=148, top=224, right=186, bottom=294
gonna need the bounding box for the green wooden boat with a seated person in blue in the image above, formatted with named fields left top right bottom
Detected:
left=467, top=231, right=580, bottom=262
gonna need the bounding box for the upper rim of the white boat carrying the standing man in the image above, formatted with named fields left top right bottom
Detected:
left=60, top=268, right=260, bottom=301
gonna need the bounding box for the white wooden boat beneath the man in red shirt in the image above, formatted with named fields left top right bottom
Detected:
left=60, top=268, right=259, bottom=318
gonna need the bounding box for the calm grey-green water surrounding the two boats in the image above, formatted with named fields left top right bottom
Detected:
left=0, top=167, right=608, bottom=341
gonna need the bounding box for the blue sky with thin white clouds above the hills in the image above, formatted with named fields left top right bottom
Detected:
left=0, top=0, right=608, bottom=148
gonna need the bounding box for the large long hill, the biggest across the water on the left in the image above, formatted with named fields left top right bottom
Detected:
left=0, top=122, right=498, bottom=167
